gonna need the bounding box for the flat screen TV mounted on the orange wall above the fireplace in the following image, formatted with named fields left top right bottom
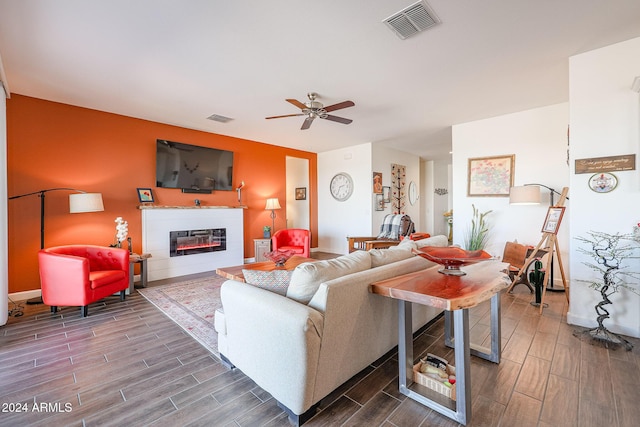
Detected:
left=156, top=139, right=233, bottom=193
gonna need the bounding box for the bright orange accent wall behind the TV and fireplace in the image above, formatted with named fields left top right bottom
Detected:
left=7, top=94, right=318, bottom=293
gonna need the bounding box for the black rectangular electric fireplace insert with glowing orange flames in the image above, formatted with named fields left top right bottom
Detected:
left=169, top=228, right=227, bottom=257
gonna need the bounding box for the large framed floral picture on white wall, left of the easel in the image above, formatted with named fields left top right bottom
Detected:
left=467, top=154, right=516, bottom=197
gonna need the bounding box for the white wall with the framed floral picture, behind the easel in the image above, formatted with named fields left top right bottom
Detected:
left=452, top=103, right=573, bottom=268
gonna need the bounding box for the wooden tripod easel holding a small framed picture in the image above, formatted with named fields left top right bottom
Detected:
left=509, top=187, right=569, bottom=314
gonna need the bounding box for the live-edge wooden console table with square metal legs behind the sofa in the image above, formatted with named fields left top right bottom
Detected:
left=370, top=261, right=511, bottom=425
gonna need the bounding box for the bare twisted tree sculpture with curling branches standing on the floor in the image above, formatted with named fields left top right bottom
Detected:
left=577, top=231, right=640, bottom=350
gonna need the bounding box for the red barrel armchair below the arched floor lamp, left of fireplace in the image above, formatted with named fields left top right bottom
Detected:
left=38, top=245, right=129, bottom=317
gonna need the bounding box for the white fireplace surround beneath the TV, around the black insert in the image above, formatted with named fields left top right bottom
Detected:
left=139, top=205, right=245, bottom=281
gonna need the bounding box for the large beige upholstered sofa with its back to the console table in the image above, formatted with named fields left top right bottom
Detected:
left=215, top=236, right=447, bottom=424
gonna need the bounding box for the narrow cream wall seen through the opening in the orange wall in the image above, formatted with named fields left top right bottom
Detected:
left=285, top=156, right=310, bottom=230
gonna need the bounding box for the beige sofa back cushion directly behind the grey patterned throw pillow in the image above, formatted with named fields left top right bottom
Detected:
left=286, top=251, right=371, bottom=304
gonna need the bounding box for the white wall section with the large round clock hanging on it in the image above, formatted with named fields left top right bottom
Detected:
left=318, top=143, right=373, bottom=254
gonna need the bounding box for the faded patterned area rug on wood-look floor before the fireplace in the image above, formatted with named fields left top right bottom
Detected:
left=138, top=274, right=226, bottom=357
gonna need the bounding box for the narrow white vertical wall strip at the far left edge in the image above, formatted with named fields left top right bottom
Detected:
left=0, top=80, right=9, bottom=325
